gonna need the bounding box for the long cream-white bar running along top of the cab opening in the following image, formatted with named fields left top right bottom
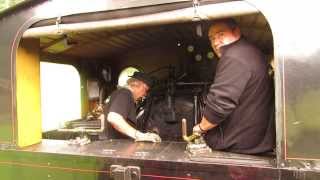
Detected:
left=23, top=1, right=259, bottom=38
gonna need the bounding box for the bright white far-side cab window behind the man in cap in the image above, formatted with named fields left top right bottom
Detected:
left=40, top=62, right=81, bottom=132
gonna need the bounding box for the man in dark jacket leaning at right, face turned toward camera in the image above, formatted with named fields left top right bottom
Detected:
left=193, top=19, right=275, bottom=154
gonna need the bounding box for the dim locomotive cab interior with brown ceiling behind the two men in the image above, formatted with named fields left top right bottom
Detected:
left=34, top=14, right=273, bottom=146
